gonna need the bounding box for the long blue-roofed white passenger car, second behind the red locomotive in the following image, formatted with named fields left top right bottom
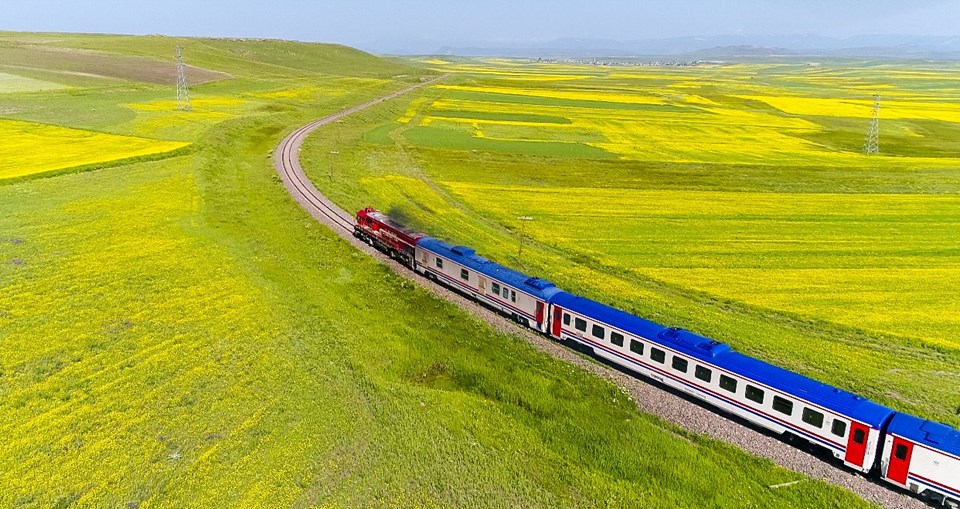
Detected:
left=550, top=292, right=894, bottom=472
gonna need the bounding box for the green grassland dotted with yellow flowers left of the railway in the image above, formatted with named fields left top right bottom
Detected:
left=0, top=34, right=867, bottom=508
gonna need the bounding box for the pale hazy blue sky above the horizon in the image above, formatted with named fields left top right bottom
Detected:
left=0, top=0, right=960, bottom=47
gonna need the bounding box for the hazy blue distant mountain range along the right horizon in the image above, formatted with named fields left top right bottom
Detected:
left=360, top=35, right=960, bottom=59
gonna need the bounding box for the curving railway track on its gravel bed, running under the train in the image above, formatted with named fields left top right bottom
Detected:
left=274, top=75, right=929, bottom=509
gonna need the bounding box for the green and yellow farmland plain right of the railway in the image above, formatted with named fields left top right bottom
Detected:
left=305, top=56, right=960, bottom=427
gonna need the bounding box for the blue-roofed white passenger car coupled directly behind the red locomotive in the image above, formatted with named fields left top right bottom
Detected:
left=416, top=237, right=560, bottom=333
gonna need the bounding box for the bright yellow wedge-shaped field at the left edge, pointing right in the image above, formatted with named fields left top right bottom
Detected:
left=0, top=120, right=188, bottom=179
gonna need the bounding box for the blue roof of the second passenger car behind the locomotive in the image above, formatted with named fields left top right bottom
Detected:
left=550, top=292, right=894, bottom=428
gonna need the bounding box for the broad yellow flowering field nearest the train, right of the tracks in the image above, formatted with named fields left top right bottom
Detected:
left=444, top=182, right=960, bottom=349
